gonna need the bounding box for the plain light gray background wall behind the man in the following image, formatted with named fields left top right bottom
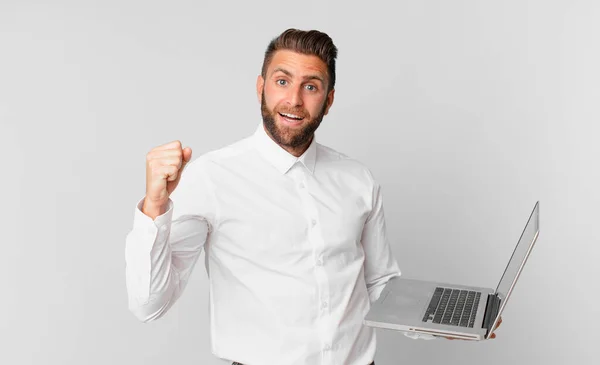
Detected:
left=0, top=0, right=600, bottom=365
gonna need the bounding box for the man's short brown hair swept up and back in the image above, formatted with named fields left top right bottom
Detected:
left=261, top=28, right=337, bottom=91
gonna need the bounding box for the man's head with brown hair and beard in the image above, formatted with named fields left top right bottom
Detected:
left=256, top=29, right=337, bottom=156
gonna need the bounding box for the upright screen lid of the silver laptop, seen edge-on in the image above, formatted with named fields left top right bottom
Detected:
left=496, top=202, right=540, bottom=301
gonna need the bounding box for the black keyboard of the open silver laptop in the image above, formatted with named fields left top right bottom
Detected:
left=423, top=287, right=481, bottom=328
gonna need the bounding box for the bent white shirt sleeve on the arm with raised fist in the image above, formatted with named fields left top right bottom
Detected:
left=125, top=162, right=214, bottom=322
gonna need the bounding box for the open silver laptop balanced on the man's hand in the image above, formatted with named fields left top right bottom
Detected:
left=364, top=201, right=540, bottom=341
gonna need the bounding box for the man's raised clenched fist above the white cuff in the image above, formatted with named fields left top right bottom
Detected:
left=142, top=141, right=192, bottom=219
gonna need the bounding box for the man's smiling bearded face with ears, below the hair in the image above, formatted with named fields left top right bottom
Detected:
left=256, top=50, right=334, bottom=150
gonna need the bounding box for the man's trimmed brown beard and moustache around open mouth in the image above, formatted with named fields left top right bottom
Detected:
left=260, top=89, right=327, bottom=148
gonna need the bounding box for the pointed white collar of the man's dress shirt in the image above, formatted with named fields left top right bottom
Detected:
left=253, top=122, right=317, bottom=174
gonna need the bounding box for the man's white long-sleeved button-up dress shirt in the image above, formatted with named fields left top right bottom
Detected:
left=125, top=122, right=426, bottom=365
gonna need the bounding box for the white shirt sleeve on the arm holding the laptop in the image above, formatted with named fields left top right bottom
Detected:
left=361, top=175, right=401, bottom=303
